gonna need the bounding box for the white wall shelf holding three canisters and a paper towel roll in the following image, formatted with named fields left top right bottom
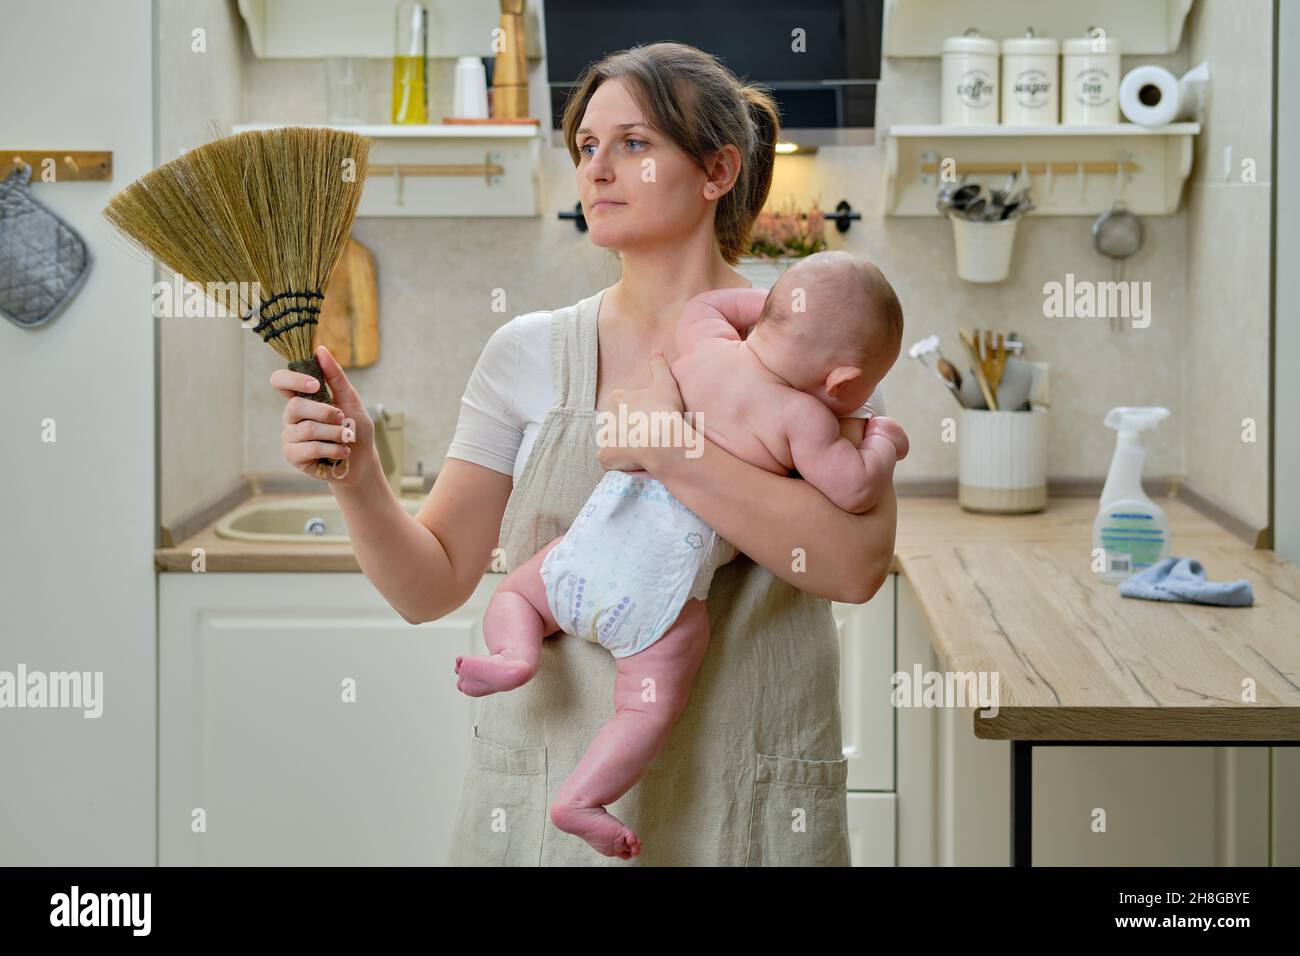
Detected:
left=885, top=122, right=1201, bottom=216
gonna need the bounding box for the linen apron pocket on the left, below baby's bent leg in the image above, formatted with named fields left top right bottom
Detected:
left=454, top=723, right=546, bottom=866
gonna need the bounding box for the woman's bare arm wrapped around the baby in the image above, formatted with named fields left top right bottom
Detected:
left=598, top=355, right=897, bottom=604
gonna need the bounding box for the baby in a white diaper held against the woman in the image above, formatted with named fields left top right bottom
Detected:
left=456, top=252, right=907, bottom=860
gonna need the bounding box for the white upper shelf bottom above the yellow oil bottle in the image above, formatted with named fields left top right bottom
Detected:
left=239, top=0, right=542, bottom=60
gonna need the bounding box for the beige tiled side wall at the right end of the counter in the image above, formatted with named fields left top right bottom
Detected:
left=1190, top=0, right=1286, bottom=538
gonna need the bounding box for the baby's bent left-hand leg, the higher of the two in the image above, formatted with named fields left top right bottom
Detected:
left=456, top=537, right=560, bottom=697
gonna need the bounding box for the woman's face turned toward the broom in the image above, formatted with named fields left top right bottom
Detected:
left=576, top=79, right=740, bottom=252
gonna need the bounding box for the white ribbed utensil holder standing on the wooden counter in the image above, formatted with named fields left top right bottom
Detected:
left=957, top=407, right=1048, bottom=514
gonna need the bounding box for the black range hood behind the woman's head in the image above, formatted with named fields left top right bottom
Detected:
left=542, top=0, right=883, bottom=146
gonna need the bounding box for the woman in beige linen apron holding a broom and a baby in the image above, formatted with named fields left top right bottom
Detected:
left=272, top=43, right=896, bottom=865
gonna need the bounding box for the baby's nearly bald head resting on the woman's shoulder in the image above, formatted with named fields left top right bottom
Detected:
left=746, top=251, right=902, bottom=415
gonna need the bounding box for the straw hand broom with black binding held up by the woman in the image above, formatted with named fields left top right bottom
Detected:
left=104, top=126, right=371, bottom=479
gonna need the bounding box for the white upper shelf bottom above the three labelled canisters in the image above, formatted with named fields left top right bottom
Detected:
left=883, top=0, right=1192, bottom=56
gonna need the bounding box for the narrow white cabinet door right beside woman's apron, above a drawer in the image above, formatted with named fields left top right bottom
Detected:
left=831, top=574, right=897, bottom=791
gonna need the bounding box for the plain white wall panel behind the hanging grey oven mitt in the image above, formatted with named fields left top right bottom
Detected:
left=0, top=0, right=157, bottom=865
